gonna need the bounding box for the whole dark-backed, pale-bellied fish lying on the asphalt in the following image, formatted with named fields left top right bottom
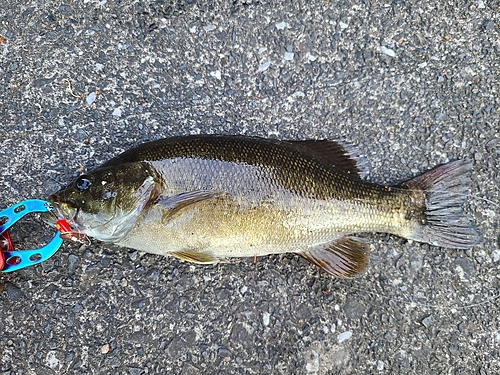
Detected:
left=43, top=135, right=482, bottom=278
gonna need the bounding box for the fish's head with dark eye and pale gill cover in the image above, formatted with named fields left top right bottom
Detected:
left=42, top=163, right=158, bottom=242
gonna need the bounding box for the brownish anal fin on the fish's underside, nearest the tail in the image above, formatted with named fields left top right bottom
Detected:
left=299, top=237, right=370, bottom=277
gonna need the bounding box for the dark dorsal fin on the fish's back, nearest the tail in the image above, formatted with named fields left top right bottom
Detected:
left=285, top=139, right=364, bottom=177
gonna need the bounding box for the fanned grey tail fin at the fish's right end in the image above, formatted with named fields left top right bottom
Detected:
left=401, top=160, right=481, bottom=249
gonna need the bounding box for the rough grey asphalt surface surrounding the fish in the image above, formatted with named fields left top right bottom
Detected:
left=0, top=0, right=500, bottom=375
